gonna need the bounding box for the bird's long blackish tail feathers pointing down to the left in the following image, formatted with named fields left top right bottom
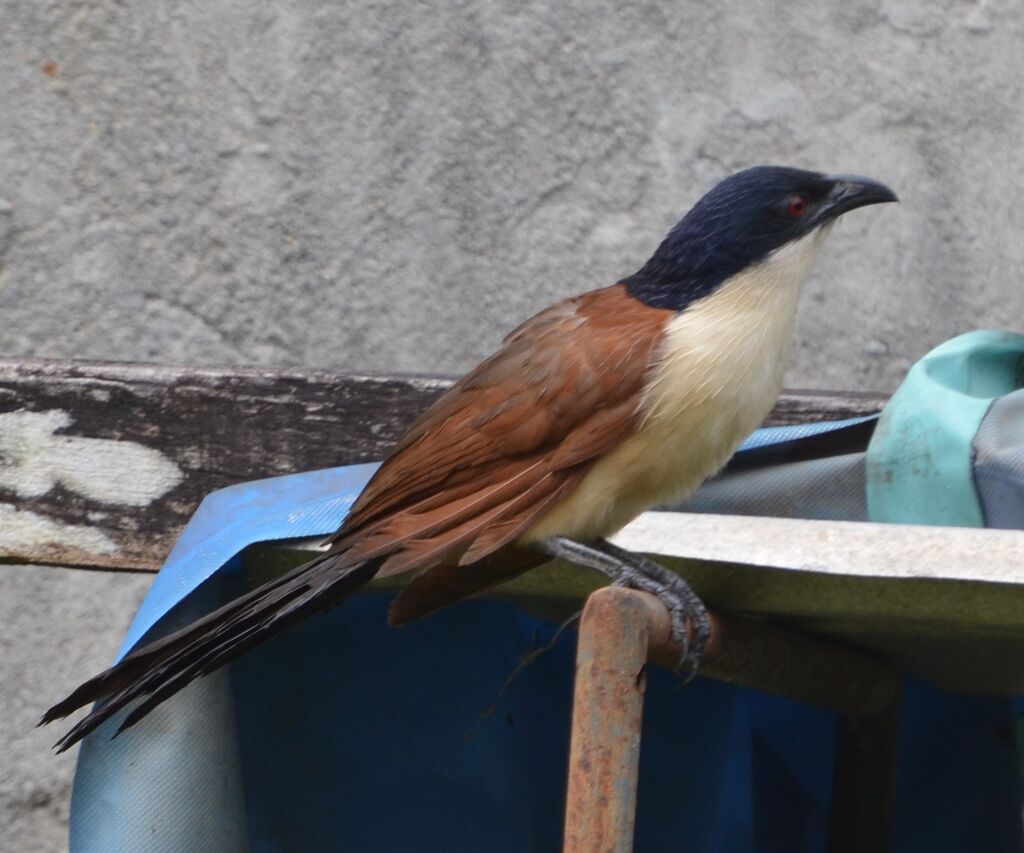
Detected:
left=39, top=554, right=380, bottom=753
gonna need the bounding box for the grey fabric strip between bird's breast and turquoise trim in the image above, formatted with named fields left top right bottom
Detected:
left=671, top=453, right=867, bottom=521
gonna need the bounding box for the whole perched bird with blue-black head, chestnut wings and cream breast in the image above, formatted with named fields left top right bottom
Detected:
left=40, top=166, right=898, bottom=752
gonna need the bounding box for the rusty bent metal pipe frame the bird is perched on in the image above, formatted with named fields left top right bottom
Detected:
left=563, top=587, right=899, bottom=853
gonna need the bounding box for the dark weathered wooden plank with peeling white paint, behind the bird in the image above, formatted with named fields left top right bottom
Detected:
left=0, top=360, right=885, bottom=570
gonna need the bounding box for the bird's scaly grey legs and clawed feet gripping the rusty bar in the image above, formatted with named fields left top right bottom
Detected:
left=534, top=537, right=711, bottom=680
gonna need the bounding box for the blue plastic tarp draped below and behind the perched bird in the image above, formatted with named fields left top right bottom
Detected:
left=72, top=342, right=1020, bottom=853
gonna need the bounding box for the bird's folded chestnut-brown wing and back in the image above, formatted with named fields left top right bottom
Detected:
left=323, top=285, right=672, bottom=577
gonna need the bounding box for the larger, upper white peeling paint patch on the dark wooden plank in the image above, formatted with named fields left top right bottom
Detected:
left=0, top=409, right=183, bottom=507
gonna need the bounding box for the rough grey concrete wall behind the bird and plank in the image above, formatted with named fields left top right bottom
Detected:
left=0, top=0, right=1024, bottom=853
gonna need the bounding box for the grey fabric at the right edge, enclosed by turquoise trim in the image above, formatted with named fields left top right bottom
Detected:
left=972, top=390, right=1024, bottom=529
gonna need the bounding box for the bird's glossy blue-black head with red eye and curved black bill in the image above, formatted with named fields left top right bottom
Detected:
left=624, top=166, right=897, bottom=310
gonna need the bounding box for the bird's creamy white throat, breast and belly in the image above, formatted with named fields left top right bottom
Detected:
left=521, top=228, right=827, bottom=542
